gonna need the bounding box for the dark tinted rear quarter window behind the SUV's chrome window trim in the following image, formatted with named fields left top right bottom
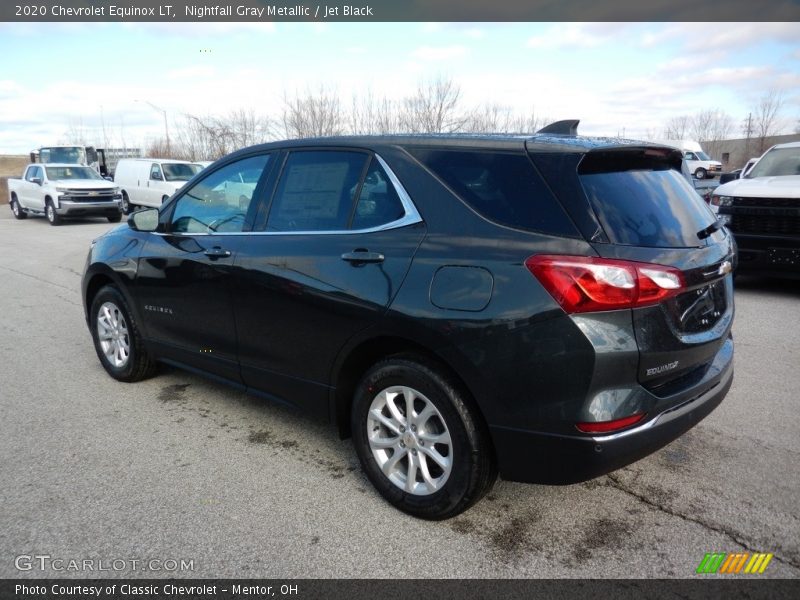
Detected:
left=410, top=149, right=578, bottom=237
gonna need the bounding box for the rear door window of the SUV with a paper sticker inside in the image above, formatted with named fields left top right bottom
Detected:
left=267, top=151, right=369, bottom=231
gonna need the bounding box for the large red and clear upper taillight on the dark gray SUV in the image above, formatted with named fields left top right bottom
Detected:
left=525, top=255, right=684, bottom=313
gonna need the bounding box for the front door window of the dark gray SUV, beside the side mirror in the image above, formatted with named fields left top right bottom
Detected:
left=171, top=154, right=270, bottom=233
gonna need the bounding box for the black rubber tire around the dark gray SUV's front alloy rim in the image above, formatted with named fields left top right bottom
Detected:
left=89, top=285, right=157, bottom=382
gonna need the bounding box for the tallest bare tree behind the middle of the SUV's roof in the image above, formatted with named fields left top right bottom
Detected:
left=399, top=76, right=467, bottom=133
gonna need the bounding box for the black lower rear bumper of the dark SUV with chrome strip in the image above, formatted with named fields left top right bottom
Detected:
left=490, top=340, right=733, bottom=485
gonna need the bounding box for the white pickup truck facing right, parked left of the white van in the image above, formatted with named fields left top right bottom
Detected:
left=8, top=163, right=122, bottom=225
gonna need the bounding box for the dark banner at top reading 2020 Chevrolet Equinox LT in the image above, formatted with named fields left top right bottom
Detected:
left=0, top=0, right=800, bottom=23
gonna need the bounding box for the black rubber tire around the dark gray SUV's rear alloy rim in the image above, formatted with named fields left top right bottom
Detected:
left=351, top=355, right=497, bottom=520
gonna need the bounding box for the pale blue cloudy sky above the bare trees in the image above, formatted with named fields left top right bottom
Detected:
left=0, top=23, right=800, bottom=154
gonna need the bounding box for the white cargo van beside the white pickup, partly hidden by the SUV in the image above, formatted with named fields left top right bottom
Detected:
left=114, top=158, right=202, bottom=214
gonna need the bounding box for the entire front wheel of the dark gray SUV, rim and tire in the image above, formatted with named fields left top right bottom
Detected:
left=89, top=285, right=156, bottom=381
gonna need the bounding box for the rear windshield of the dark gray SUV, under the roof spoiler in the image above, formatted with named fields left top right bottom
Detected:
left=578, top=153, right=716, bottom=248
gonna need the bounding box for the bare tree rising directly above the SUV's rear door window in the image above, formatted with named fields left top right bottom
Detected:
left=281, top=87, right=347, bottom=138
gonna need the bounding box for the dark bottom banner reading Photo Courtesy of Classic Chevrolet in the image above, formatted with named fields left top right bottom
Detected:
left=0, top=577, right=800, bottom=600
